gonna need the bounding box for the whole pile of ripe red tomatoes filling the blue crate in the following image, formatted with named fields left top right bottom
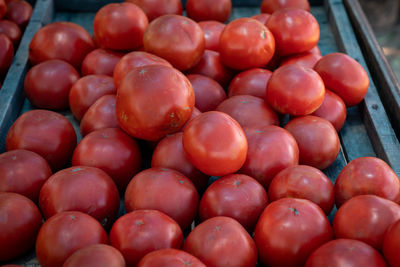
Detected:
left=0, top=0, right=400, bottom=267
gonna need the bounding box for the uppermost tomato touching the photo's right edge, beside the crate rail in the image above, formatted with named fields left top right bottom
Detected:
left=335, top=157, right=400, bottom=207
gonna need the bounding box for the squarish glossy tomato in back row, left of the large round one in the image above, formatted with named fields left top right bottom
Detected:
left=93, top=3, right=149, bottom=50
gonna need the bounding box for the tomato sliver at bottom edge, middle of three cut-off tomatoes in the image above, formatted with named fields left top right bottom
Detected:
left=137, top=248, right=206, bottom=267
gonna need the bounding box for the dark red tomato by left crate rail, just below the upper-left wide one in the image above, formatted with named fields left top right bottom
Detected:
left=24, top=59, right=80, bottom=110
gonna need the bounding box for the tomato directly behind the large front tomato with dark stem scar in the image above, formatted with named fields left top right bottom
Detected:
left=268, top=165, right=335, bottom=215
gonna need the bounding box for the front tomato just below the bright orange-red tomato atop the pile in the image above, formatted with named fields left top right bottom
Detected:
left=199, top=174, right=268, bottom=233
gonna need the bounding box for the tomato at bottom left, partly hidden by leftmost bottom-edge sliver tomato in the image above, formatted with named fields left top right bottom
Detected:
left=36, top=211, right=108, bottom=267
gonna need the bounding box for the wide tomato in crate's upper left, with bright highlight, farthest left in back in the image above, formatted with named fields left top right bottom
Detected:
left=29, top=22, right=94, bottom=70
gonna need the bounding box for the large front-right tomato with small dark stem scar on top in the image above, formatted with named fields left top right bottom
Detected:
left=254, top=198, right=333, bottom=267
